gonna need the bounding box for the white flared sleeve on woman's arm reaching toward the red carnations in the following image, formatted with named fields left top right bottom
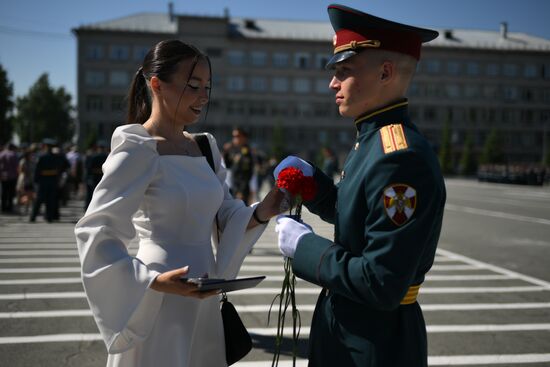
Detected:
left=207, top=134, right=267, bottom=279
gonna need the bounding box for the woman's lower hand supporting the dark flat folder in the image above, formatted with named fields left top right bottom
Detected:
left=151, top=266, right=220, bottom=299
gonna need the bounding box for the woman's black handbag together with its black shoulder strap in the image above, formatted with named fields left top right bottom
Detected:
left=195, top=134, right=252, bottom=366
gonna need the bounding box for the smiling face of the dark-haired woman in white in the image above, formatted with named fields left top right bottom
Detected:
left=161, top=57, right=210, bottom=125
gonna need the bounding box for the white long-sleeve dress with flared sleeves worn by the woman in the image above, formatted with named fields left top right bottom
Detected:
left=75, top=124, right=266, bottom=367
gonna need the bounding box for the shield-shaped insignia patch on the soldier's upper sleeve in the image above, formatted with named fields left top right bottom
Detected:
left=384, top=184, right=416, bottom=226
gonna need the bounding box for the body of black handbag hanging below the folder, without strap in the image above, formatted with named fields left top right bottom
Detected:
left=220, top=293, right=252, bottom=366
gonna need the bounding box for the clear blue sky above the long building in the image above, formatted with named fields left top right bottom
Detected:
left=0, top=0, right=550, bottom=103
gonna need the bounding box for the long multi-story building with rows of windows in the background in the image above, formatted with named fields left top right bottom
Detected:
left=74, top=6, right=550, bottom=162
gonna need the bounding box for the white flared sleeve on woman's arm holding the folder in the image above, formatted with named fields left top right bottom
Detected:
left=75, top=126, right=163, bottom=353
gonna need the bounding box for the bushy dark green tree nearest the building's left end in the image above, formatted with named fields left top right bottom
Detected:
left=15, top=73, right=74, bottom=143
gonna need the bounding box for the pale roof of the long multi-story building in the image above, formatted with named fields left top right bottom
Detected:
left=77, top=13, right=550, bottom=51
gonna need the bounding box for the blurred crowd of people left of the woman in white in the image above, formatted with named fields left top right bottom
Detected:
left=0, top=139, right=108, bottom=223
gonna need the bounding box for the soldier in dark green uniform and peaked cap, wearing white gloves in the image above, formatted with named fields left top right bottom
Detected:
left=274, top=5, right=446, bottom=367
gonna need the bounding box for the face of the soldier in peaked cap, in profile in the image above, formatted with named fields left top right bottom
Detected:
left=330, top=51, right=382, bottom=118
